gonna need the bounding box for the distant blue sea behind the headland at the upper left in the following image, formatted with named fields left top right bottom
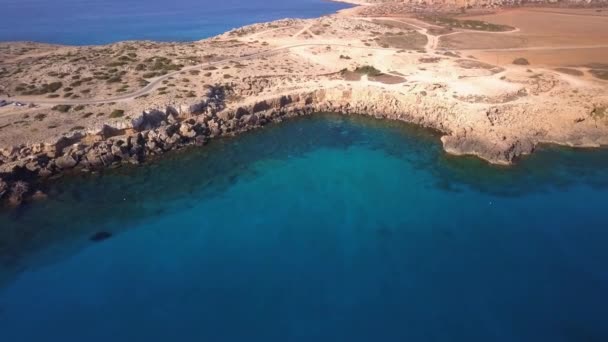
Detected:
left=0, top=0, right=348, bottom=45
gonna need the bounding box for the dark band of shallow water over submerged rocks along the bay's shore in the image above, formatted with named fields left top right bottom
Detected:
left=0, top=114, right=608, bottom=286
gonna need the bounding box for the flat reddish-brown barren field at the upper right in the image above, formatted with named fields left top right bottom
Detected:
left=439, top=8, right=608, bottom=66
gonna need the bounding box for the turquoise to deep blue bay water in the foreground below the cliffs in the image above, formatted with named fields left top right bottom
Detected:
left=0, top=115, right=608, bottom=342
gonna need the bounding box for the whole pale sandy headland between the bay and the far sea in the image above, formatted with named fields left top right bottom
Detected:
left=0, top=4, right=608, bottom=204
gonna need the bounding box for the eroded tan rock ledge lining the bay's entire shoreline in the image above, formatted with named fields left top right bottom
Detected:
left=0, top=84, right=608, bottom=206
